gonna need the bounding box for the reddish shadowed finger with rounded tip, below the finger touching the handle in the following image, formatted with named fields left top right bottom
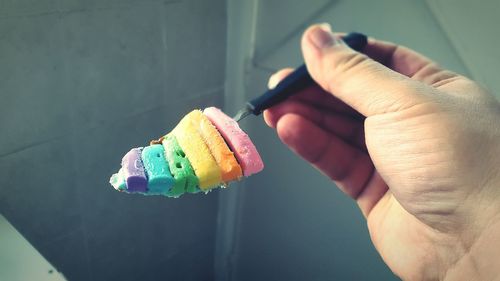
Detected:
left=276, top=114, right=374, bottom=198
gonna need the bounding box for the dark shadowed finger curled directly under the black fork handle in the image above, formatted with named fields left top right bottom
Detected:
left=264, top=100, right=367, bottom=152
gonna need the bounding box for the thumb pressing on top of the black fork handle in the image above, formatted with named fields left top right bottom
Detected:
left=302, top=24, right=422, bottom=117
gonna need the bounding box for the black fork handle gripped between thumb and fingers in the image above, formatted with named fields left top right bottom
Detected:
left=247, top=32, right=367, bottom=115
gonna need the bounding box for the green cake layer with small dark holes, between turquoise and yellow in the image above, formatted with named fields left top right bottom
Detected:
left=162, top=135, right=201, bottom=197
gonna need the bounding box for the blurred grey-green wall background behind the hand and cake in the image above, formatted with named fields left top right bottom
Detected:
left=0, top=0, right=500, bottom=281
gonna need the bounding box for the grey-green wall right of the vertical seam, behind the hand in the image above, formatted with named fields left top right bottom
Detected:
left=221, top=0, right=500, bottom=281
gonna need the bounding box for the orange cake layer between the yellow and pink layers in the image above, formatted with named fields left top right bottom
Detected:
left=200, top=114, right=243, bottom=183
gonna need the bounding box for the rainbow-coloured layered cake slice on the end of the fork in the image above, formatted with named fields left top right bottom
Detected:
left=110, top=107, right=264, bottom=197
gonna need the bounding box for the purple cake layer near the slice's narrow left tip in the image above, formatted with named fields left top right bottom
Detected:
left=122, top=147, right=148, bottom=192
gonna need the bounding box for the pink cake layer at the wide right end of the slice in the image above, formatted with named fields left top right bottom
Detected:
left=203, top=107, right=264, bottom=177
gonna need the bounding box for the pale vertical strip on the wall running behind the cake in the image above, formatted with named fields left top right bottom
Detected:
left=214, top=0, right=258, bottom=281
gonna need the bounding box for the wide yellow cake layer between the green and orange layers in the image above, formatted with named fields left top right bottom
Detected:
left=172, top=110, right=222, bottom=190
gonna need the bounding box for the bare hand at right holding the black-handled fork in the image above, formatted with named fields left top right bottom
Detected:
left=264, top=25, right=500, bottom=280
